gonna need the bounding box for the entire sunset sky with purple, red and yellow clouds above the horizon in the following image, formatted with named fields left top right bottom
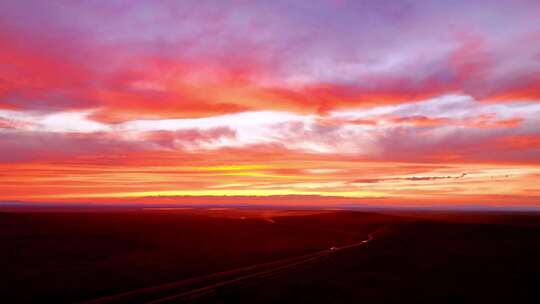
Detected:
left=0, top=0, right=540, bottom=207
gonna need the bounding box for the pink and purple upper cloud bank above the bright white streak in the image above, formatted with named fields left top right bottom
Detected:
left=0, top=1, right=540, bottom=122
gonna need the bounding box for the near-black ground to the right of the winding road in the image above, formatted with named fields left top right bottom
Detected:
left=208, top=218, right=540, bottom=303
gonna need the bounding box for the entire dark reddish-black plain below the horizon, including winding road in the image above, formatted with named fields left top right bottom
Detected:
left=0, top=209, right=540, bottom=303
